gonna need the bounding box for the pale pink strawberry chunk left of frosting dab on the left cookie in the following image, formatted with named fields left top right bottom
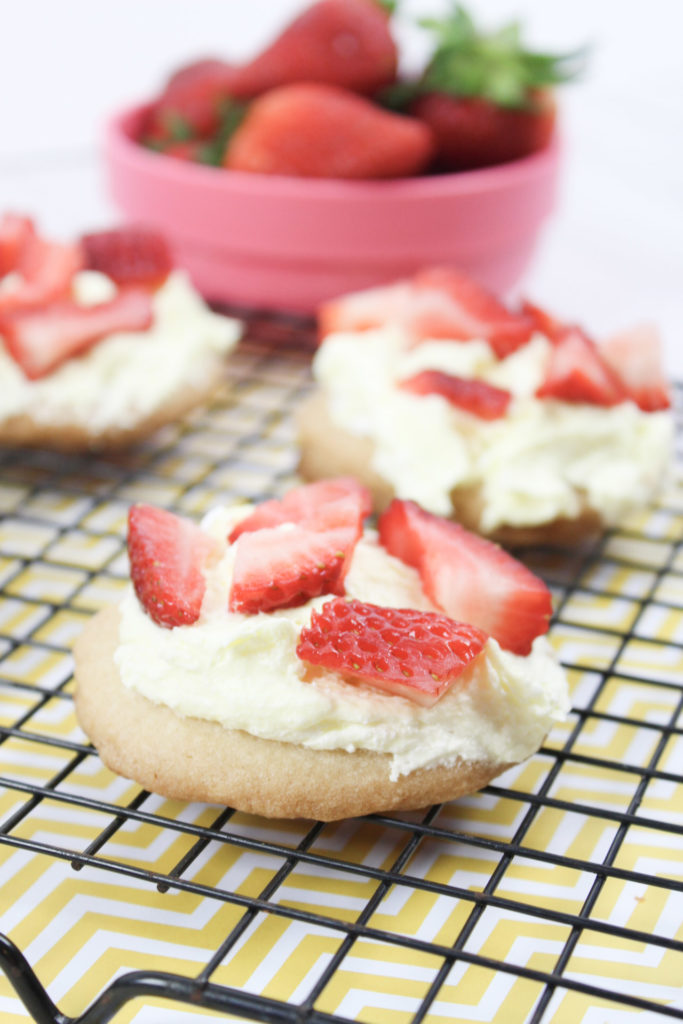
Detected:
left=0, top=232, right=83, bottom=316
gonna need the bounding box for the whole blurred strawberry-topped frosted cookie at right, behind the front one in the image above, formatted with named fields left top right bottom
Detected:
left=297, top=267, right=674, bottom=544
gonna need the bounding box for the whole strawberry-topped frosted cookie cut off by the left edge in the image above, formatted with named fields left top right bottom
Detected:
left=0, top=213, right=240, bottom=451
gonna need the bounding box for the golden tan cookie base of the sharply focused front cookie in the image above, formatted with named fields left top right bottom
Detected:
left=74, top=606, right=511, bottom=821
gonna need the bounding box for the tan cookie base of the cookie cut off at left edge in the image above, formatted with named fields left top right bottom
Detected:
left=0, top=372, right=222, bottom=454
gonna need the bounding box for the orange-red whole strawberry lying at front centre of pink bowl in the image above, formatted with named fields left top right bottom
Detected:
left=223, top=83, right=432, bottom=178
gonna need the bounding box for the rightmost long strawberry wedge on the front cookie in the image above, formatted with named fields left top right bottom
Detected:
left=379, top=500, right=552, bottom=654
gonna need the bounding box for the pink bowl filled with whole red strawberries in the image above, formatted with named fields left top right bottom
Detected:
left=106, top=0, right=577, bottom=313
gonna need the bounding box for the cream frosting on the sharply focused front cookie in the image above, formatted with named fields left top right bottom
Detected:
left=116, top=507, right=568, bottom=780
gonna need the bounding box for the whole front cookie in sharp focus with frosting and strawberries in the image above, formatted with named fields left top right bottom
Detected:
left=75, top=477, right=568, bottom=820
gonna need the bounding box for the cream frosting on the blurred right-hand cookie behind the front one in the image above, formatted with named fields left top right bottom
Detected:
left=313, top=327, right=673, bottom=532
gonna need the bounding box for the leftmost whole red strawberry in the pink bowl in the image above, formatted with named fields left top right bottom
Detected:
left=143, top=59, right=233, bottom=142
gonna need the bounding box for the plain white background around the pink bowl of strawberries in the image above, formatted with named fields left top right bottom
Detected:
left=0, top=0, right=683, bottom=378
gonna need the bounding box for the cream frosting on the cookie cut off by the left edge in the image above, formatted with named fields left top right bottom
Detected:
left=0, top=270, right=241, bottom=434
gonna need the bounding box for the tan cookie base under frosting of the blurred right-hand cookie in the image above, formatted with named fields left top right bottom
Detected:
left=296, top=392, right=604, bottom=547
